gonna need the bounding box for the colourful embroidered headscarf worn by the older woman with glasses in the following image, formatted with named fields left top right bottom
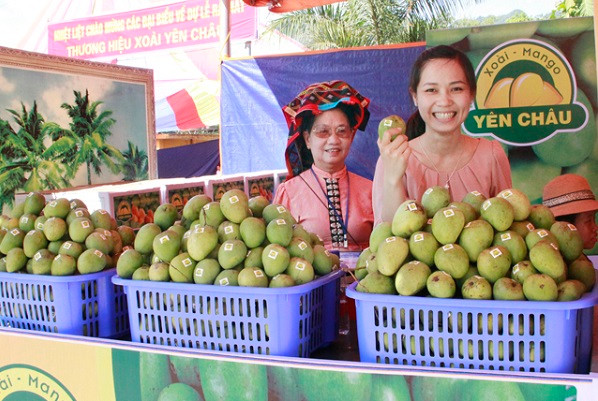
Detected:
left=282, top=81, right=370, bottom=179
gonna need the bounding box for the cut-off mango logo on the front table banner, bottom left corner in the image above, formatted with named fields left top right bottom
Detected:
left=0, top=365, right=76, bottom=401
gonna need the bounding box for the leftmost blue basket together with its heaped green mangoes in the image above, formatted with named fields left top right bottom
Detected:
left=0, top=192, right=135, bottom=338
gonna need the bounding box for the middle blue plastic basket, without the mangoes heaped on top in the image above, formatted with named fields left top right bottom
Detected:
left=112, top=270, right=344, bottom=357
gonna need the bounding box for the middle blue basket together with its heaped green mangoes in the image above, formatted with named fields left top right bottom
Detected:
left=113, top=189, right=344, bottom=356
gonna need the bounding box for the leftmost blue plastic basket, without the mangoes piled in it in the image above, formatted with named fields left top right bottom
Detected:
left=0, top=269, right=129, bottom=338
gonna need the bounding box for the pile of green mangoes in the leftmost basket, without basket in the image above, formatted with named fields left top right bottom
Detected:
left=0, top=192, right=135, bottom=276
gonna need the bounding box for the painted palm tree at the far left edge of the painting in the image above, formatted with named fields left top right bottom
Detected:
left=0, top=102, right=70, bottom=205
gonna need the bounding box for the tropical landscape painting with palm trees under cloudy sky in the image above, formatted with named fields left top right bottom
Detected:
left=0, top=47, right=153, bottom=207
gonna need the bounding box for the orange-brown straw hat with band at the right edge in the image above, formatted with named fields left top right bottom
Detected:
left=542, top=174, right=598, bottom=217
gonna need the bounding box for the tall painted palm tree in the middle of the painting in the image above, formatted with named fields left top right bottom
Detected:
left=46, top=90, right=124, bottom=185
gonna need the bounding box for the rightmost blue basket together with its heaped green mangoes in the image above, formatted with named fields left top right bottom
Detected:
left=347, top=187, right=598, bottom=373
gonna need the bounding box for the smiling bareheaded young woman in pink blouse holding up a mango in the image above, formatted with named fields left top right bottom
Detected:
left=372, top=45, right=512, bottom=223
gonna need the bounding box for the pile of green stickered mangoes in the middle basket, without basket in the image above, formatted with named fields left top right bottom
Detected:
left=116, top=189, right=339, bottom=288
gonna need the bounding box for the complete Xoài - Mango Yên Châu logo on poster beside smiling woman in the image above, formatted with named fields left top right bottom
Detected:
left=464, top=39, right=588, bottom=146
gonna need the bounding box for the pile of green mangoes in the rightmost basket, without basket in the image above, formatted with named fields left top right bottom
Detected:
left=355, top=186, right=596, bottom=301
